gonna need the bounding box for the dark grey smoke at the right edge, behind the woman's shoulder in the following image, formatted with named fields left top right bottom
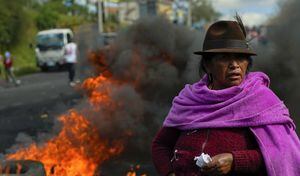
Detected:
left=255, top=0, right=300, bottom=132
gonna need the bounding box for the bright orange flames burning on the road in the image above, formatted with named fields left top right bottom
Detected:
left=6, top=42, right=152, bottom=176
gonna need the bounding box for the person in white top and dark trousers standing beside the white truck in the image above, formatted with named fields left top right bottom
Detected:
left=64, top=35, right=77, bottom=87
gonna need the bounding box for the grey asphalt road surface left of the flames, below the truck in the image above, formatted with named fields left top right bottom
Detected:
left=0, top=72, right=82, bottom=153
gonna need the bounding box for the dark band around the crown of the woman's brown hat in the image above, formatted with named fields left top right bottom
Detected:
left=203, top=40, right=249, bottom=50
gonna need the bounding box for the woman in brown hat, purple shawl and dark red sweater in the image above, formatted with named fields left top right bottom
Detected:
left=152, top=15, right=300, bottom=176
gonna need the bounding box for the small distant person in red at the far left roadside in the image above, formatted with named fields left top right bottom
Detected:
left=3, top=51, right=21, bottom=86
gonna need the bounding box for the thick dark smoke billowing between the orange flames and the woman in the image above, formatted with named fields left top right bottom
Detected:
left=86, top=17, right=203, bottom=160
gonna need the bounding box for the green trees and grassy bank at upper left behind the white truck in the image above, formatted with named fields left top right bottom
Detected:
left=0, top=0, right=96, bottom=75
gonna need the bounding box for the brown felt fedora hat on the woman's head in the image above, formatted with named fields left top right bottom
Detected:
left=194, top=21, right=256, bottom=55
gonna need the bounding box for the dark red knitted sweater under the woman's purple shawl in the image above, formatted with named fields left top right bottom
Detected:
left=152, top=127, right=267, bottom=176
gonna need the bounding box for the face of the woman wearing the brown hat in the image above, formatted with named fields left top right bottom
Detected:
left=205, top=53, right=249, bottom=89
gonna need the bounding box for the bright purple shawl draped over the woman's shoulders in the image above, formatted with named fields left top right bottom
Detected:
left=163, top=72, right=300, bottom=176
